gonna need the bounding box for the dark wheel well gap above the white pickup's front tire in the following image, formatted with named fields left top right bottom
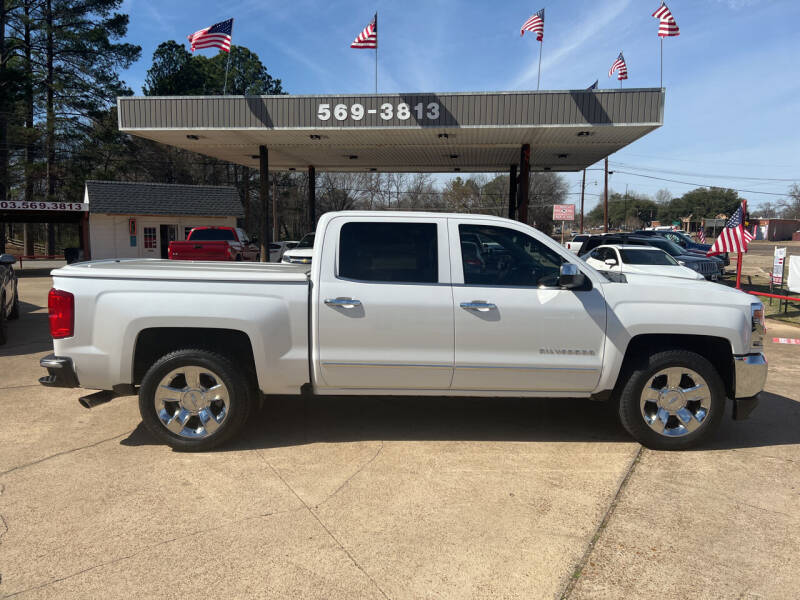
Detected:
left=618, top=333, right=735, bottom=398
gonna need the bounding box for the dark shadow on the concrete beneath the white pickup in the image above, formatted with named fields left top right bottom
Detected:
left=120, top=393, right=800, bottom=452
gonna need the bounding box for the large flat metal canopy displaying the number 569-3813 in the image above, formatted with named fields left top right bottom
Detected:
left=117, top=88, right=664, bottom=172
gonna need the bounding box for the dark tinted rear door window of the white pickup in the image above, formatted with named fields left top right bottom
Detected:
left=339, top=222, right=439, bottom=283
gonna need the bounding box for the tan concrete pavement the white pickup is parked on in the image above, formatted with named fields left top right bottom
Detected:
left=0, top=277, right=800, bottom=598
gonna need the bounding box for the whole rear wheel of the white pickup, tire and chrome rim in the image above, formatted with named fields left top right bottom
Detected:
left=139, top=349, right=250, bottom=451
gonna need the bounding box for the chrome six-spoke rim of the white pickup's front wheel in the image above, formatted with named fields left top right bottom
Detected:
left=639, top=367, right=711, bottom=437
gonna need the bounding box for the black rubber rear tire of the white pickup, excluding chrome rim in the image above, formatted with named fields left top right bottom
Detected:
left=139, top=349, right=255, bottom=452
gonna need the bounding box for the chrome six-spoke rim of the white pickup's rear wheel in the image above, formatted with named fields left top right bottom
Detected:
left=153, top=365, right=230, bottom=439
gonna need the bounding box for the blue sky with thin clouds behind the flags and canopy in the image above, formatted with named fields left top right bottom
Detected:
left=123, top=0, right=800, bottom=213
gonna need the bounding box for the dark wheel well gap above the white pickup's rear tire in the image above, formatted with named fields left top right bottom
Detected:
left=133, top=327, right=256, bottom=385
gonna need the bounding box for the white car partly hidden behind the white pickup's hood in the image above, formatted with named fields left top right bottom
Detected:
left=586, top=245, right=705, bottom=280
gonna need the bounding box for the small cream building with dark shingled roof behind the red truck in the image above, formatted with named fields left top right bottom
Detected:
left=84, top=180, right=243, bottom=260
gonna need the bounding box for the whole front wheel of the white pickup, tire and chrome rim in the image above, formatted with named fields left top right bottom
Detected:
left=619, top=350, right=725, bottom=450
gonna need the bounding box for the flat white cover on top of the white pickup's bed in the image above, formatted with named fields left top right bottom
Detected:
left=52, top=258, right=310, bottom=282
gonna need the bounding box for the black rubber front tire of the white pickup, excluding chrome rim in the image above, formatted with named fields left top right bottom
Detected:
left=618, top=350, right=725, bottom=450
